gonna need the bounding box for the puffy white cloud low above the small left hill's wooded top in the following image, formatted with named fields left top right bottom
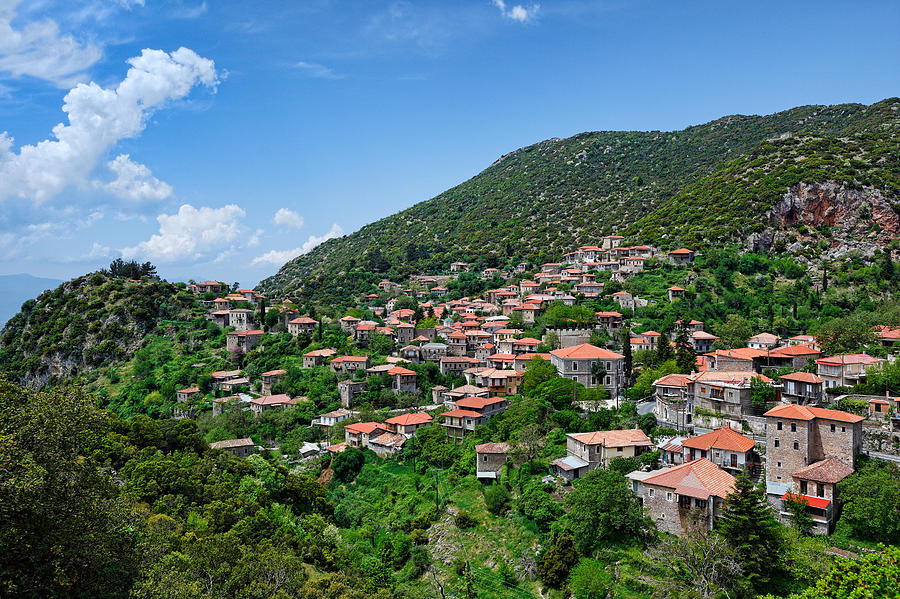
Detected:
left=122, top=204, right=246, bottom=263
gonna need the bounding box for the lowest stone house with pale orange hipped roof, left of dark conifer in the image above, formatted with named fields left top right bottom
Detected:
left=627, top=458, right=735, bottom=536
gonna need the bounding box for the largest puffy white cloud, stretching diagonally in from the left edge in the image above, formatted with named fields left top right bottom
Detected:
left=0, top=46, right=218, bottom=203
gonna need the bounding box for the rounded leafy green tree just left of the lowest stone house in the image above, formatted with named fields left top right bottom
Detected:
left=566, top=470, right=654, bottom=555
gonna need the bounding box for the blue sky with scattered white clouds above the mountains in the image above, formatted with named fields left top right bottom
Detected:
left=0, top=0, right=900, bottom=285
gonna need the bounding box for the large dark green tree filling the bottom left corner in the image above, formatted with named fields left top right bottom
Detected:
left=0, top=379, right=138, bottom=598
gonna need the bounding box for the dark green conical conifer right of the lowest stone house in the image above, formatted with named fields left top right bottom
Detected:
left=718, top=471, right=782, bottom=591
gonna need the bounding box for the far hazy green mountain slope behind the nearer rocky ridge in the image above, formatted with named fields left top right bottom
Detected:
left=259, top=99, right=900, bottom=301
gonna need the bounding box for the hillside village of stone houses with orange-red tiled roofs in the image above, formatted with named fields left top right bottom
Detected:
left=177, top=235, right=900, bottom=535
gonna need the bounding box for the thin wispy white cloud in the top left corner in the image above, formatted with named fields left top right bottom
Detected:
left=0, top=0, right=102, bottom=87
